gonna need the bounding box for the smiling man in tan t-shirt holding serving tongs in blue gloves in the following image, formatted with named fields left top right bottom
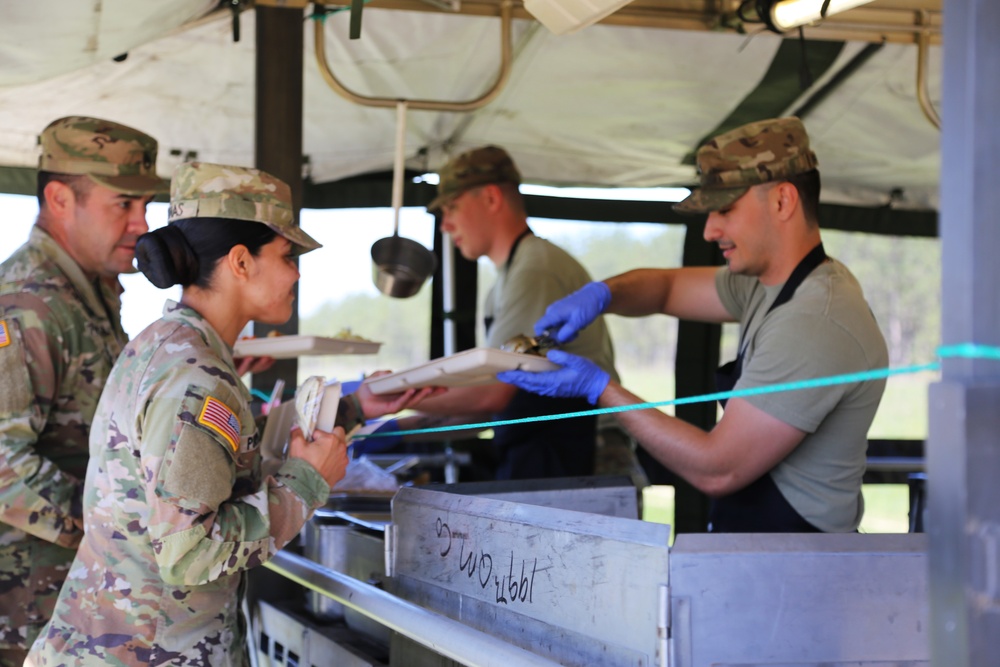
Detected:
left=498, top=118, right=888, bottom=532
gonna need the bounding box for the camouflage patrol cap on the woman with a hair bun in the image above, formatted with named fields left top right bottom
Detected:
left=167, top=162, right=323, bottom=255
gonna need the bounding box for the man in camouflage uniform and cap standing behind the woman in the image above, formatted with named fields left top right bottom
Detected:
left=0, top=117, right=167, bottom=665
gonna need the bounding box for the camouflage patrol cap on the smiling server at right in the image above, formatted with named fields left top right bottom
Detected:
left=674, top=117, right=817, bottom=213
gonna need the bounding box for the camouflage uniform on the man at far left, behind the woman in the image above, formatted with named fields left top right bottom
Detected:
left=0, top=226, right=128, bottom=649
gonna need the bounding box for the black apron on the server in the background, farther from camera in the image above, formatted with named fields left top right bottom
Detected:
left=484, top=229, right=597, bottom=479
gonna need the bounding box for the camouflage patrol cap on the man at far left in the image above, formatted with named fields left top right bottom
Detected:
left=38, top=116, right=170, bottom=195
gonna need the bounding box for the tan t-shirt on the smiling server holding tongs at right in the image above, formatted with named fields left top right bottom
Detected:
left=716, top=260, right=889, bottom=532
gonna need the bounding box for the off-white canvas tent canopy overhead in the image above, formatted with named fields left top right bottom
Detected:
left=0, top=0, right=940, bottom=210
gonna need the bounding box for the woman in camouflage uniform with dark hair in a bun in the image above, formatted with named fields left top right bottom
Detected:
left=26, top=163, right=428, bottom=667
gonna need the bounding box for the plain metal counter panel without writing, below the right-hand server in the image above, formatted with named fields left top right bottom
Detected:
left=668, top=534, right=930, bottom=667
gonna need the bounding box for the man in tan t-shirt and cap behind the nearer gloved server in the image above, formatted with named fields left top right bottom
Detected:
left=386, top=146, right=645, bottom=486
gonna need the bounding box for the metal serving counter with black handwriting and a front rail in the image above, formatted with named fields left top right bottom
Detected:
left=255, top=478, right=929, bottom=667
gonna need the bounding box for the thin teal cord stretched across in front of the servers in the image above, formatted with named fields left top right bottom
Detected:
left=352, top=343, right=1000, bottom=440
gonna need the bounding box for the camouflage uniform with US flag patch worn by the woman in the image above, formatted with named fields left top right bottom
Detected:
left=29, top=301, right=330, bottom=667
